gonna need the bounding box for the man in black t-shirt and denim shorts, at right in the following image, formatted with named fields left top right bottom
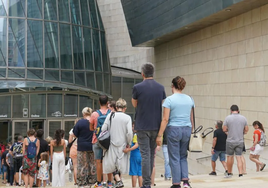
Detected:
left=209, top=121, right=228, bottom=176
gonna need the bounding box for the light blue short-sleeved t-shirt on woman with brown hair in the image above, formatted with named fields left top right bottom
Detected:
left=163, top=93, right=194, bottom=127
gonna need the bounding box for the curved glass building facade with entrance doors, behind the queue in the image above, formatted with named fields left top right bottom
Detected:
left=0, top=0, right=111, bottom=143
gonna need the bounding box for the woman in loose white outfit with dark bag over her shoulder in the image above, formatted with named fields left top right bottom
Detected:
left=101, top=98, right=133, bottom=187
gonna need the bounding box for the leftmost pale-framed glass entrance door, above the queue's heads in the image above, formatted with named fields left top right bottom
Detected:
left=12, top=120, right=29, bottom=143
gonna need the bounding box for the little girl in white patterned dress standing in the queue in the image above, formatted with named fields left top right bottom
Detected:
left=37, top=152, right=49, bottom=187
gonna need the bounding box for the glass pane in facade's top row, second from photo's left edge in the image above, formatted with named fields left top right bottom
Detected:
left=9, top=0, right=25, bottom=17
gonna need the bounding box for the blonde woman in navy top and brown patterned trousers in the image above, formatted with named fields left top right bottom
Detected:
left=73, top=107, right=97, bottom=186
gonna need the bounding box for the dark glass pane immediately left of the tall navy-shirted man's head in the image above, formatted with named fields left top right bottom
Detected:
left=122, top=78, right=134, bottom=112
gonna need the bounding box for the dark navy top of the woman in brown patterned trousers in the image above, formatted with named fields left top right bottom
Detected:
left=73, top=119, right=93, bottom=151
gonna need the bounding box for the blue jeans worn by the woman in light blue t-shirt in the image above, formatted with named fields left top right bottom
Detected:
left=166, top=126, right=192, bottom=184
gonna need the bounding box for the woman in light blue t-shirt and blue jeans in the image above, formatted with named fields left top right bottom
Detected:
left=156, top=76, right=194, bottom=188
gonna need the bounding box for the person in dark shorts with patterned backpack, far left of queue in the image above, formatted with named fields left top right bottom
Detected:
left=9, top=135, right=23, bottom=185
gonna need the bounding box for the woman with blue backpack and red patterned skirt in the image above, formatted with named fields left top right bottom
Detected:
left=22, top=129, right=40, bottom=188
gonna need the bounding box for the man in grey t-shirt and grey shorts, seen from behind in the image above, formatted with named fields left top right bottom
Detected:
left=223, top=105, right=248, bottom=178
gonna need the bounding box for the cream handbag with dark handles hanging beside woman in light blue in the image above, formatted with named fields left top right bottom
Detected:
left=189, top=108, right=214, bottom=152
